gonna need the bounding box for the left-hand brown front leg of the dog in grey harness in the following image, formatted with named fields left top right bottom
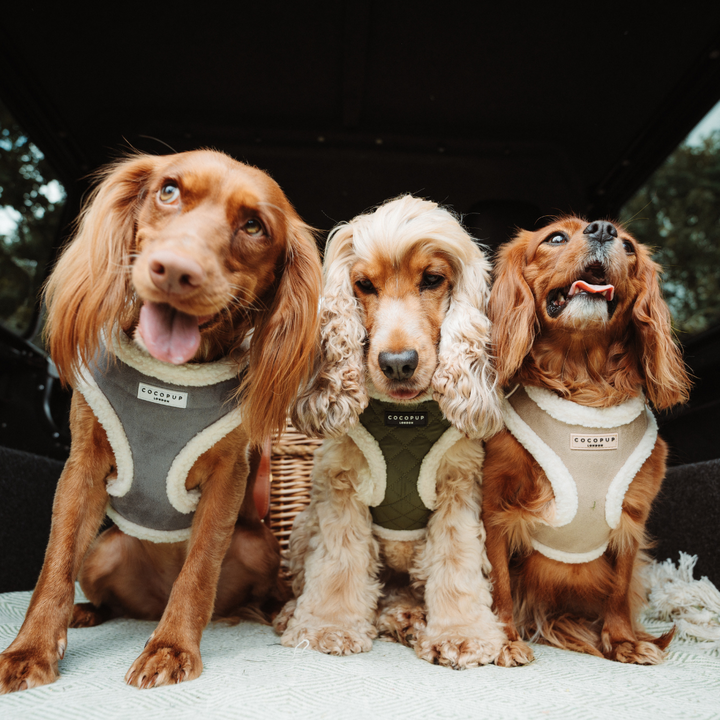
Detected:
left=0, top=393, right=113, bottom=693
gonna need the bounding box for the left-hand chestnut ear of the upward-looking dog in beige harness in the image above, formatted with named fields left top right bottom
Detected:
left=488, top=230, right=539, bottom=386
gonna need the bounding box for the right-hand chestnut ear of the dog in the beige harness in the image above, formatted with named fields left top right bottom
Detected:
left=632, top=246, right=691, bottom=410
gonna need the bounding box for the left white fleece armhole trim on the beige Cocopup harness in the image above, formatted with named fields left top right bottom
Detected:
left=502, top=399, right=578, bottom=527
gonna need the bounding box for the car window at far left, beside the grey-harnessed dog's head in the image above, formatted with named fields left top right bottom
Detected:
left=0, top=96, right=66, bottom=335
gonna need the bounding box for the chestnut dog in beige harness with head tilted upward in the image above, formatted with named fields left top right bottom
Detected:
left=483, top=217, right=689, bottom=665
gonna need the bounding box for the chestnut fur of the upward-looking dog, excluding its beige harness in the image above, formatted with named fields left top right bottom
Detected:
left=483, top=217, right=689, bottom=665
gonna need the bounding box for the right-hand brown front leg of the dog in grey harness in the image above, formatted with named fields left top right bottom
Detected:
left=125, top=429, right=249, bottom=688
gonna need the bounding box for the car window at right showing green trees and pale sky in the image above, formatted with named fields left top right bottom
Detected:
left=620, top=98, right=720, bottom=335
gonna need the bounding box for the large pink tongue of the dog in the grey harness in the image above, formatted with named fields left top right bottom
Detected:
left=138, top=302, right=200, bottom=365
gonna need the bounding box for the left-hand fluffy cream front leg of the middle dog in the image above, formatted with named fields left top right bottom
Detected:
left=281, top=447, right=380, bottom=655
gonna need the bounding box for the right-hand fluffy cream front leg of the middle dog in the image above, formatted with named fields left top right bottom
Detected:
left=412, top=440, right=507, bottom=669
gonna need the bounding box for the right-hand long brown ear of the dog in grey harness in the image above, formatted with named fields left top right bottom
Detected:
left=243, top=211, right=322, bottom=445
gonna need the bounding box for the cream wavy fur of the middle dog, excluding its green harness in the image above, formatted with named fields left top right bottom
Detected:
left=275, top=196, right=506, bottom=668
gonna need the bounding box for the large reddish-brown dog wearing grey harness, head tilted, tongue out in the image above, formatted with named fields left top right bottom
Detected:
left=0, top=151, right=320, bottom=692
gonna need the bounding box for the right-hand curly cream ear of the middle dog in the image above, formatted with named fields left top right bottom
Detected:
left=432, top=248, right=502, bottom=438
